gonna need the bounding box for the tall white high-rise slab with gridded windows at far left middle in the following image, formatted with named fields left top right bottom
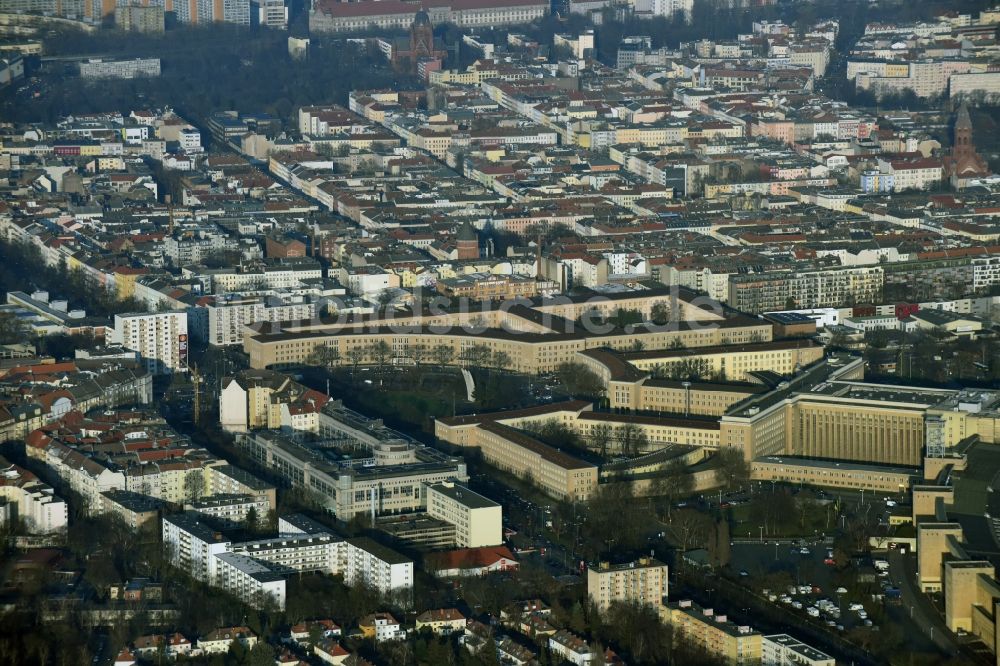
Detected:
left=111, top=312, right=188, bottom=375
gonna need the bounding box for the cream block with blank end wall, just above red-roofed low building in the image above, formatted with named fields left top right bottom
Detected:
left=427, top=481, right=503, bottom=548
